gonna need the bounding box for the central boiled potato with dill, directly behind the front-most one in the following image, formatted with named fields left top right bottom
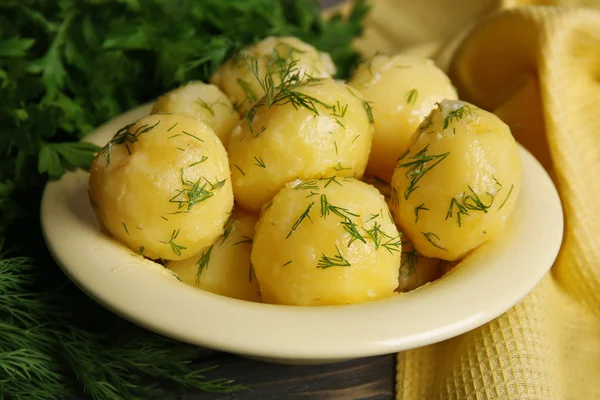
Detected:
left=227, top=79, right=373, bottom=216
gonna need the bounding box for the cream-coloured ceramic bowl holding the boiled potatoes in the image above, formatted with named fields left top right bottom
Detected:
left=42, top=105, right=563, bottom=364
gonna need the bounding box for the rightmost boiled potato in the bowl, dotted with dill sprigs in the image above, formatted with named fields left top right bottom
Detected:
left=392, top=100, right=521, bottom=260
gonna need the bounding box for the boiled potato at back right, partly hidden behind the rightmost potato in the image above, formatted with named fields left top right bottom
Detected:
left=348, top=55, right=458, bottom=182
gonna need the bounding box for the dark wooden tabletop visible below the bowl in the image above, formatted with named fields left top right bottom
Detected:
left=185, top=350, right=396, bottom=400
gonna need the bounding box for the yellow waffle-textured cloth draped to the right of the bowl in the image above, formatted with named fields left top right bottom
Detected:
left=342, top=0, right=600, bottom=400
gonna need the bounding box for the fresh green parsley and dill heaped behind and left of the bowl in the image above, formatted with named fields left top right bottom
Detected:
left=0, top=0, right=368, bottom=400
